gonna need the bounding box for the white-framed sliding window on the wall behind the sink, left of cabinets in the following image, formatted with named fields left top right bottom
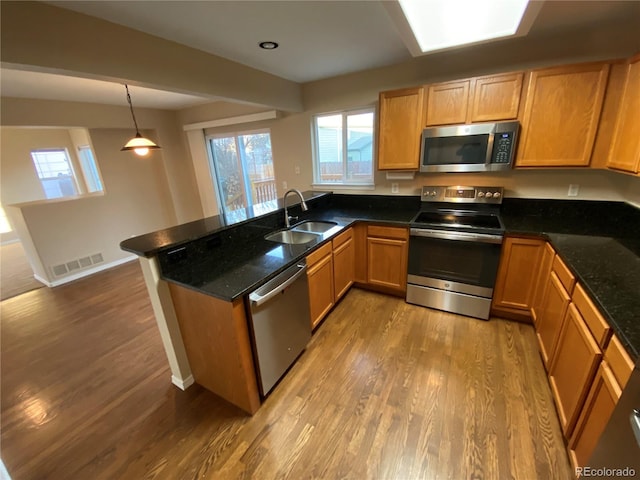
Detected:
left=313, top=107, right=374, bottom=187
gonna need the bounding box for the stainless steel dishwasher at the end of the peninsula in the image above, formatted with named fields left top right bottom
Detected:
left=249, top=260, right=311, bottom=395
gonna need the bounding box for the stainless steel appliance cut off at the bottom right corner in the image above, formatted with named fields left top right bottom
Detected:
left=588, top=361, right=640, bottom=478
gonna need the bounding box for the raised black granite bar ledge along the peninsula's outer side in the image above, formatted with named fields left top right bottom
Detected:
left=120, top=190, right=333, bottom=258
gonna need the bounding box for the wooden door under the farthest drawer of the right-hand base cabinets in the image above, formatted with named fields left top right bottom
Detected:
left=536, top=272, right=571, bottom=367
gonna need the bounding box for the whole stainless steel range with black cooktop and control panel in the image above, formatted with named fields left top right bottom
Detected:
left=406, top=186, right=504, bottom=320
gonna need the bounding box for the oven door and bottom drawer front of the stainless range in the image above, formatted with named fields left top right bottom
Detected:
left=407, top=228, right=503, bottom=319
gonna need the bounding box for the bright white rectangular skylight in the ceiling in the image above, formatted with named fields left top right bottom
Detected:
left=398, top=0, right=528, bottom=53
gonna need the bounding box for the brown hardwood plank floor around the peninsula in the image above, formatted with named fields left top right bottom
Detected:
left=1, top=263, right=572, bottom=480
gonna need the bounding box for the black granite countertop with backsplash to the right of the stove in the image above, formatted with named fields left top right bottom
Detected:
left=501, top=199, right=640, bottom=361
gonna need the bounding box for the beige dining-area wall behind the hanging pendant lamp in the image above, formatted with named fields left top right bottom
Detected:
left=0, top=98, right=192, bottom=283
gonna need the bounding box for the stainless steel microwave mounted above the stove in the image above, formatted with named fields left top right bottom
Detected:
left=420, top=121, right=520, bottom=172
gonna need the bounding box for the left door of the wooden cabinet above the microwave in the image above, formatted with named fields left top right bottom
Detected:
left=426, top=80, right=471, bottom=126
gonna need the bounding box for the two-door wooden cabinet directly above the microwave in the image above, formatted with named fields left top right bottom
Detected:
left=425, top=72, right=523, bottom=126
